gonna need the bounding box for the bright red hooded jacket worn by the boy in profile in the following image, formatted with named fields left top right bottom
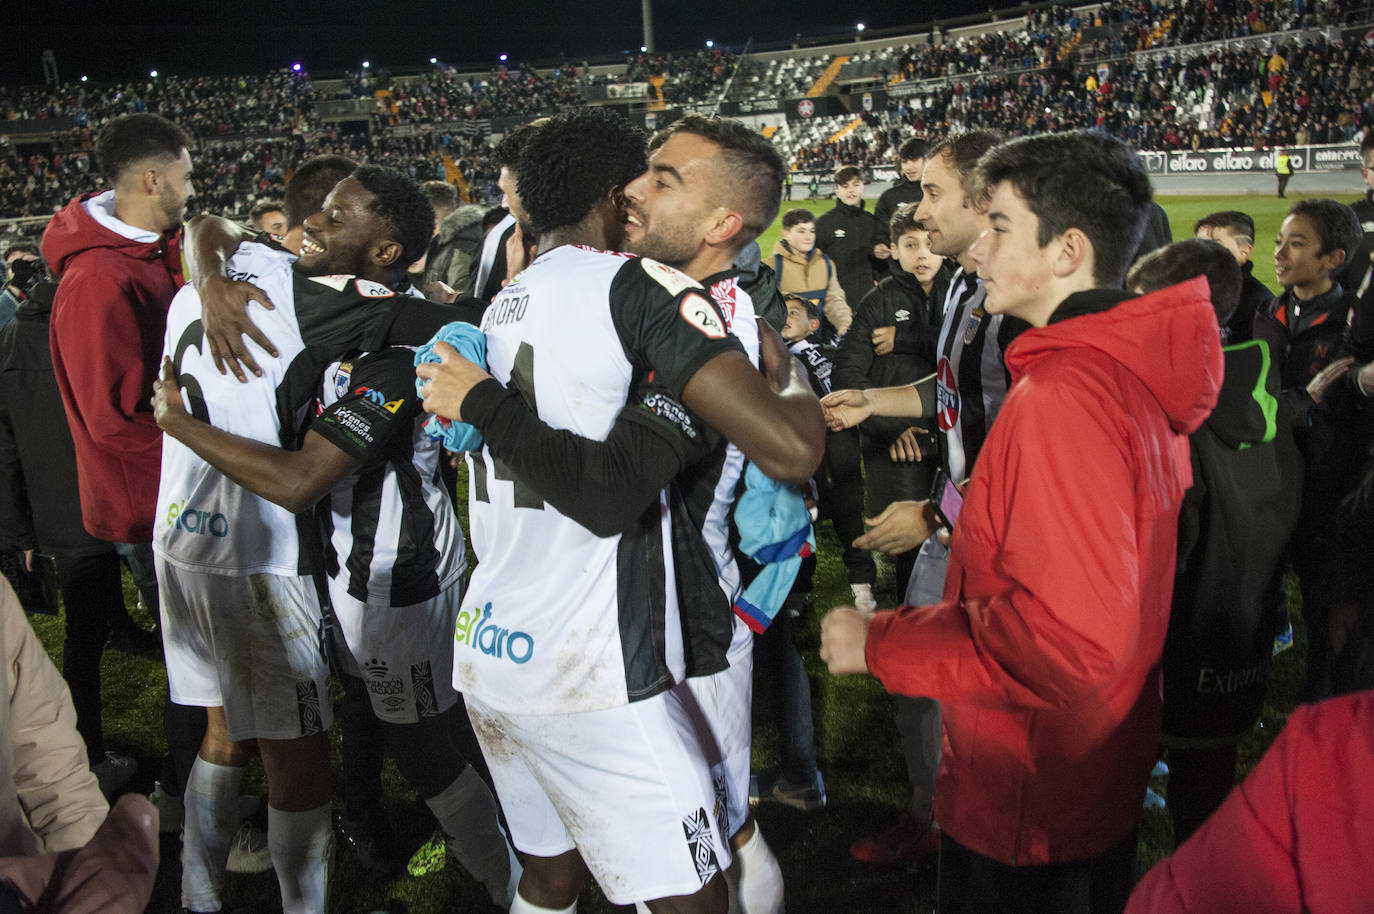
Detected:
left=867, top=278, right=1223, bottom=865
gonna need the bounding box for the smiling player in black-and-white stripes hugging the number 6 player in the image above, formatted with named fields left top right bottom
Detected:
left=159, top=166, right=519, bottom=906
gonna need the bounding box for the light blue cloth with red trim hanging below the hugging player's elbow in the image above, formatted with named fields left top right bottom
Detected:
left=735, top=463, right=816, bottom=632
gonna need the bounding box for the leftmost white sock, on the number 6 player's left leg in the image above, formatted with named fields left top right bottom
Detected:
left=181, top=756, right=246, bottom=911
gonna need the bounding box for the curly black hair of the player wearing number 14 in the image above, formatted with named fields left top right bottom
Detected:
left=517, top=109, right=647, bottom=238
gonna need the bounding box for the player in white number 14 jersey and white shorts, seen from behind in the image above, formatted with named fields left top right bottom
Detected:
left=419, top=113, right=820, bottom=911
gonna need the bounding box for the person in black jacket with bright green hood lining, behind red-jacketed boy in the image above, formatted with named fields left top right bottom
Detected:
left=1127, top=236, right=1303, bottom=844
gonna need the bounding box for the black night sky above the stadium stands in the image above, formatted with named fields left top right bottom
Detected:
left=0, top=0, right=983, bottom=84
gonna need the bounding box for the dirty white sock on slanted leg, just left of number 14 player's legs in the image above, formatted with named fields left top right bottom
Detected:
left=425, top=766, right=522, bottom=907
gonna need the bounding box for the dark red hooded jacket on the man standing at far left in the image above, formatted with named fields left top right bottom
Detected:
left=43, top=194, right=183, bottom=543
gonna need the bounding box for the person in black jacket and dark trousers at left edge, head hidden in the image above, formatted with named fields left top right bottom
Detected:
left=0, top=269, right=138, bottom=794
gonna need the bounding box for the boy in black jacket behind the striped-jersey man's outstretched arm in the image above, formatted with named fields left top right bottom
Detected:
left=834, top=203, right=951, bottom=602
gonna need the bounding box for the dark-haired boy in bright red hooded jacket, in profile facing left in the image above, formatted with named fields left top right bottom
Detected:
left=822, top=132, right=1221, bottom=914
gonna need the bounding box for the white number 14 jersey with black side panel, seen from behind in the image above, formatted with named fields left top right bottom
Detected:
left=453, top=246, right=739, bottom=713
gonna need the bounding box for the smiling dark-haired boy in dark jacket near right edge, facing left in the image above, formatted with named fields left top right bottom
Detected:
left=1254, top=199, right=1374, bottom=700
